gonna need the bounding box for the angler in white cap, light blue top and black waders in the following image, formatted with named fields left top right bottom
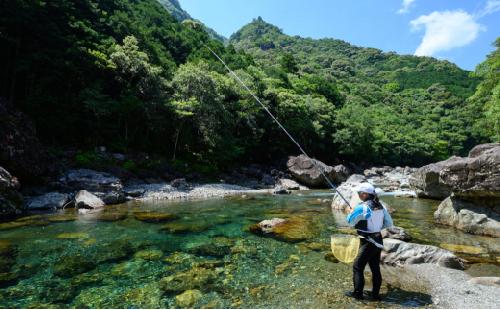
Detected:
left=346, top=182, right=392, bottom=300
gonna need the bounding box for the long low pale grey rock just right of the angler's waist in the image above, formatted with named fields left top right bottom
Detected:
left=381, top=238, right=465, bottom=270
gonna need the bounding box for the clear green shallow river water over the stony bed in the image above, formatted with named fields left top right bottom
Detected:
left=0, top=192, right=499, bottom=308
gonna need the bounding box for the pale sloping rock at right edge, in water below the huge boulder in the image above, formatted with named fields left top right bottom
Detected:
left=434, top=196, right=500, bottom=237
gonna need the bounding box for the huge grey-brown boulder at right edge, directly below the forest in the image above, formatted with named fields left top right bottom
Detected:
left=410, top=143, right=500, bottom=199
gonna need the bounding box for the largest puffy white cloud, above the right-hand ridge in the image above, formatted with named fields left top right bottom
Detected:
left=410, top=10, right=485, bottom=56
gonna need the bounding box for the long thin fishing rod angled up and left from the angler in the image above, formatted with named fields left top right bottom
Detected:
left=203, top=44, right=351, bottom=207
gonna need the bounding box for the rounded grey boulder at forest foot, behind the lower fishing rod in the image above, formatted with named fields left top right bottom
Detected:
left=287, top=155, right=349, bottom=187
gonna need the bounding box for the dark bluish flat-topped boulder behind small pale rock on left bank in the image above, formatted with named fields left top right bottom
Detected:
left=59, top=169, right=126, bottom=204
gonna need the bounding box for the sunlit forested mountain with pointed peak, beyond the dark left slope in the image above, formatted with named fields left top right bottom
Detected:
left=230, top=18, right=488, bottom=162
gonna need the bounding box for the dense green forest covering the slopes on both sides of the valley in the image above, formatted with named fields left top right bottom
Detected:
left=0, top=0, right=499, bottom=171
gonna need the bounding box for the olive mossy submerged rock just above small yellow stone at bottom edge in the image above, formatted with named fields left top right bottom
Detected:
left=160, top=267, right=217, bottom=293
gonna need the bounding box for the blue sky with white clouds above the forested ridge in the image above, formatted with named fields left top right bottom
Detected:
left=180, top=0, right=500, bottom=70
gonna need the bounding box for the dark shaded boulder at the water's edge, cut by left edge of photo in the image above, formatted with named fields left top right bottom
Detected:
left=0, top=167, right=23, bottom=217
